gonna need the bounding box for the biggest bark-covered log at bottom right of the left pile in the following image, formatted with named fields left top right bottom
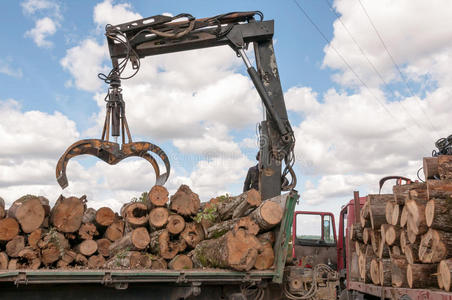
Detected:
left=192, top=229, right=262, bottom=271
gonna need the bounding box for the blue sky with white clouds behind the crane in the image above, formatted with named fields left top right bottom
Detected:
left=0, top=0, right=452, bottom=217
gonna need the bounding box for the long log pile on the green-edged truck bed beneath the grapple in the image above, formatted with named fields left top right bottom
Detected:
left=0, top=185, right=283, bottom=271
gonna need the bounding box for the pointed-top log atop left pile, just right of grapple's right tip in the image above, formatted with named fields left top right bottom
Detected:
left=170, top=184, right=201, bottom=216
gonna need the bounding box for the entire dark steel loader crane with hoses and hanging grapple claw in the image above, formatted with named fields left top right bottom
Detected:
left=56, top=11, right=296, bottom=199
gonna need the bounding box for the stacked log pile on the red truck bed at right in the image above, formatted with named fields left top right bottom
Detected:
left=349, top=155, right=452, bottom=291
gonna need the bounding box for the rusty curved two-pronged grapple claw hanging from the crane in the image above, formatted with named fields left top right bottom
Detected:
left=56, top=139, right=170, bottom=189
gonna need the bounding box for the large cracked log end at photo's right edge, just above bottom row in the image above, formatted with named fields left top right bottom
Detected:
left=419, top=229, right=452, bottom=263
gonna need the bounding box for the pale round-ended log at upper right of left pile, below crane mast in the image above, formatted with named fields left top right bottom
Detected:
left=250, top=200, right=283, bottom=232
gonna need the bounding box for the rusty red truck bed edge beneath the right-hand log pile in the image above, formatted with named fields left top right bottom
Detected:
left=349, top=281, right=452, bottom=300
